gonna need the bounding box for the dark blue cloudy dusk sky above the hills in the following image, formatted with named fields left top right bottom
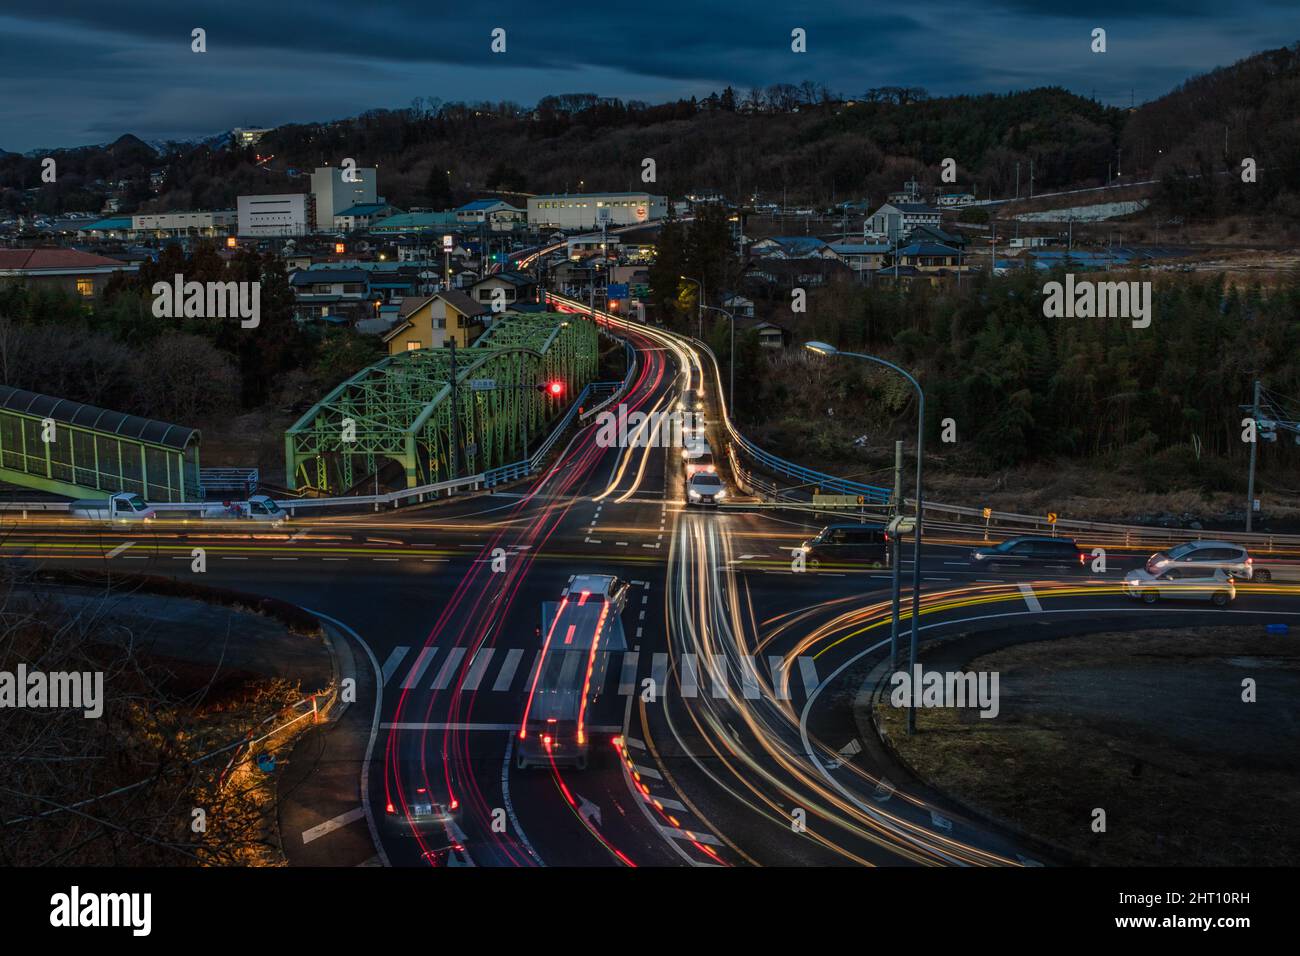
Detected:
left=0, top=0, right=1300, bottom=152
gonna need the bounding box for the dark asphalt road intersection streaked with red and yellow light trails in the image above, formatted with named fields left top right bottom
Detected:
left=10, top=316, right=1300, bottom=866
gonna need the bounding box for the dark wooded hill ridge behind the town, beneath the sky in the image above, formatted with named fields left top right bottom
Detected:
left=0, top=44, right=1300, bottom=215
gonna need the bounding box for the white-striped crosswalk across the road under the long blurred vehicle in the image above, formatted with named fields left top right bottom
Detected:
left=382, top=646, right=819, bottom=701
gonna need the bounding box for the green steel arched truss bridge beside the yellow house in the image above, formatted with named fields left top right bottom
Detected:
left=285, top=312, right=599, bottom=494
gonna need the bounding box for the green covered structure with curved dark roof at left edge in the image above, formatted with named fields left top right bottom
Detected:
left=0, top=385, right=202, bottom=502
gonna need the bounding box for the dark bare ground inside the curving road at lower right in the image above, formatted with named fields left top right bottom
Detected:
left=876, top=626, right=1300, bottom=866
